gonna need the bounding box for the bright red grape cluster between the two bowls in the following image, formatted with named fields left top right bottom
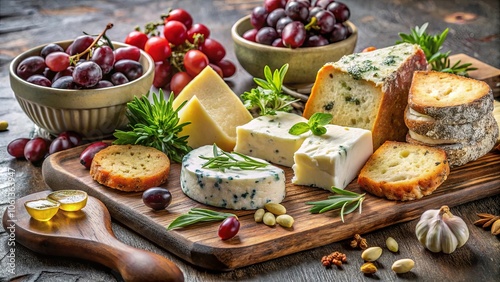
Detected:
left=125, top=9, right=236, bottom=95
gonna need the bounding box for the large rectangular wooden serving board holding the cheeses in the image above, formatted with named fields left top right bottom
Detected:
left=43, top=146, right=500, bottom=270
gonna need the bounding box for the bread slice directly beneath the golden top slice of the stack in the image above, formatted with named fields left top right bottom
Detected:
left=405, top=107, right=496, bottom=143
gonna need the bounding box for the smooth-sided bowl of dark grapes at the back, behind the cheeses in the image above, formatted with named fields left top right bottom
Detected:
left=231, top=16, right=358, bottom=84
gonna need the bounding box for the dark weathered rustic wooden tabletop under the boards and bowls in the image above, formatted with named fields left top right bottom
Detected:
left=0, top=0, right=500, bottom=281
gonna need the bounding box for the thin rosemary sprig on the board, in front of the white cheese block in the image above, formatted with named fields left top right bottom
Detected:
left=306, top=187, right=365, bottom=222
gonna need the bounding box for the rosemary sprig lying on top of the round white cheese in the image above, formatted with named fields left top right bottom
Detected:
left=198, top=144, right=269, bottom=171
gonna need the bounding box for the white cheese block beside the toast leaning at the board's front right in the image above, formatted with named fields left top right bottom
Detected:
left=292, top=125, right=373, bottom=190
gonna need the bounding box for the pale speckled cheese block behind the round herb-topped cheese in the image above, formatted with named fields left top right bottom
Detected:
left=234, top=112, right=310, bottom=167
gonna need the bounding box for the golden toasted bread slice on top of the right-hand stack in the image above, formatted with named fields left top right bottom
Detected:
left=408, top=71, right=493, bottom=124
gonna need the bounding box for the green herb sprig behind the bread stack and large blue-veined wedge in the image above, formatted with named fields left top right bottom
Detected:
left=396, top=23, right=477, bottom=76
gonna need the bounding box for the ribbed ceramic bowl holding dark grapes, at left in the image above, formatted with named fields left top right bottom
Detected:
left=9, top=40, right=154, bottom=140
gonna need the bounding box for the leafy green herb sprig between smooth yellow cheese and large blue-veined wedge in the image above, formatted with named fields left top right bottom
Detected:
left=240, top=64, right=299, bottom=116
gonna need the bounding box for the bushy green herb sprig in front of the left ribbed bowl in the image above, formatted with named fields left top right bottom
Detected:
left=113, top=89, right=192, bottom=163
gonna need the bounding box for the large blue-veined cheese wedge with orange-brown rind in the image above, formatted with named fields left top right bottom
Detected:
left=304, top=43, right=427, bottom=149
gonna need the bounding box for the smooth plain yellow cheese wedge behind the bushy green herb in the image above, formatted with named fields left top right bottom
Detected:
left=173, top=67, right=252, bottom=151
